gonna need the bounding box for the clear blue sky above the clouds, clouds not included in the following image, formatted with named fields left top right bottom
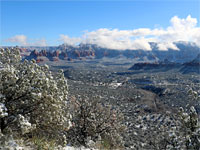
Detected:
left=0, top=0, right=200, bottom=48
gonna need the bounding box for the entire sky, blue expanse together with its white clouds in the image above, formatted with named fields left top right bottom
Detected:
left=0, top=0, right=200, bottom=50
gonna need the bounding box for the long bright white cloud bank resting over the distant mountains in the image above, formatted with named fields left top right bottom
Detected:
left=60, top=15, right=200, bottom=50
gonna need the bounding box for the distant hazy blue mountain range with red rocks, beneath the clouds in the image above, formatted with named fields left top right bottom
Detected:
left=25, top=42, right=200, bottom=63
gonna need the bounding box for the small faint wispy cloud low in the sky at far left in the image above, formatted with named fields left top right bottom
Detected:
left=5, top=35, right=47, bottom=46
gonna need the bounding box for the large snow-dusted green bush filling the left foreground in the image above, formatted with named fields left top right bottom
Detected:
left=0, top=48, right=70, bottom=142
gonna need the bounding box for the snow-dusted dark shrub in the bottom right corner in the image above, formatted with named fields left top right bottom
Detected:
left=151, top=106, right=200, bottom=150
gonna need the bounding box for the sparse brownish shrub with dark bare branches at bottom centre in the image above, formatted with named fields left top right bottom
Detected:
left=67, top=97, right=125, bottom=149
